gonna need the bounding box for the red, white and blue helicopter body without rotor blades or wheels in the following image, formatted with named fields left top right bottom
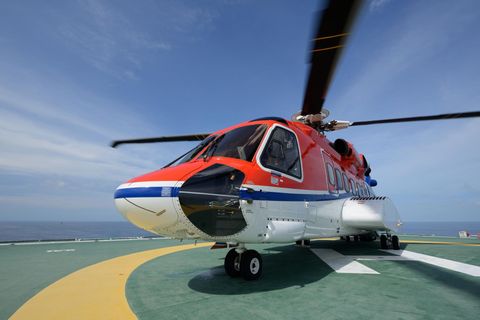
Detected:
left=115, top=119, right=399, bottom=243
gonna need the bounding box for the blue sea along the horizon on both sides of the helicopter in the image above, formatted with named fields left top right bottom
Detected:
left=0, top=221, right=480, bottom=242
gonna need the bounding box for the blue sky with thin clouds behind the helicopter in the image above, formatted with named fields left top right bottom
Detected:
left=0, top=0, right=480, bottom=221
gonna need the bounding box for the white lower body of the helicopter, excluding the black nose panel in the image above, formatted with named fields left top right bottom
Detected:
left=115, top=181, right=401, bottom=243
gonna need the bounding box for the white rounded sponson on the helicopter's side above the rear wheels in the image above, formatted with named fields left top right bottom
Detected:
left=342, top=197, right=402, bottom=232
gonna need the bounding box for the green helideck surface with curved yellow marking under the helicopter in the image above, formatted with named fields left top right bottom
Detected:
left=0, top=237, right=480, bottom=319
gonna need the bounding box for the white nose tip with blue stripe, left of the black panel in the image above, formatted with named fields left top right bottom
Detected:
left=114, top=182, right=178, bottom=235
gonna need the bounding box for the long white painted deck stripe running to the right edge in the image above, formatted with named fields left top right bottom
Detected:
left=382, top=250, right=480, bottom=277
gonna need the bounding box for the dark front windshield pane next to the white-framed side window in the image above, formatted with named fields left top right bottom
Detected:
left=204, top=124, right=267, bottom=161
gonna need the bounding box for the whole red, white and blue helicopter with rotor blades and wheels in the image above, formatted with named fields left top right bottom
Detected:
left=112, top=0, right=480, bottom=280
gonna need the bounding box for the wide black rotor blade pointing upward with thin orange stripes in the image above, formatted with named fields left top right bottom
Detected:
left=301, top=0, right=362, bottom=116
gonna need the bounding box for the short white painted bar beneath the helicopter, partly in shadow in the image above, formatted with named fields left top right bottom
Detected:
left=310, top=248, right=379, bottom=274
